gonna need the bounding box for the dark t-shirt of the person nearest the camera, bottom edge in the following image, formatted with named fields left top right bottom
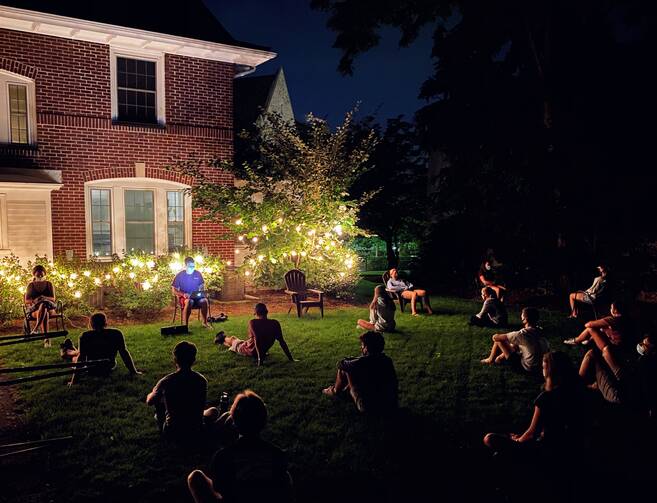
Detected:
left=209, top=437, right=291, bottom=503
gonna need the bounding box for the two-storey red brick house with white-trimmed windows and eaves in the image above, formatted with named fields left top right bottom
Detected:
left=0, top=0, right=275, bottom=260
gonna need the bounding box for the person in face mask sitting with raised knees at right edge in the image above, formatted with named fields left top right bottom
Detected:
left=579, top=335, right=657, bottom=414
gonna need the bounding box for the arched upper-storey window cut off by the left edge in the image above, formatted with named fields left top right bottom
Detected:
left=0, top=71, right=36, bottom=145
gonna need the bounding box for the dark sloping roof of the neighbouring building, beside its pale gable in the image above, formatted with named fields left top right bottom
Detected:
left=233, top=73, right=278, bottom=132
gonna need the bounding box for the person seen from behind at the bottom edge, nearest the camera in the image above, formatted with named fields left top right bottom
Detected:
left=187, top=390, right=293, bottom=503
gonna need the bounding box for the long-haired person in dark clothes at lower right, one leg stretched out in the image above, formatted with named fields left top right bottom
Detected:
left=484, top=352, right=592, bottom=452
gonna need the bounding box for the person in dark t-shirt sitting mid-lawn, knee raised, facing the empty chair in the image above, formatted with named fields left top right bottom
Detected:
left=322, top=332, right=398, bottom=413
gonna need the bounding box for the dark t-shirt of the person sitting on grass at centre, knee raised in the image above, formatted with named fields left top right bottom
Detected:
left=338, top=353, right=398, bottom=412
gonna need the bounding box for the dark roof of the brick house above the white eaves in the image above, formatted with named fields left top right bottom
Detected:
left=0, top=0, right=268, bottom=50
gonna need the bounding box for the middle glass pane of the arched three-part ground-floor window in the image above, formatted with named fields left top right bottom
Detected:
left=125, top=190, right=155, bottom=253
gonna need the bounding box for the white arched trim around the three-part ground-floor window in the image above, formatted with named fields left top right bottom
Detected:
left=84, top=178, right=192, bottom=260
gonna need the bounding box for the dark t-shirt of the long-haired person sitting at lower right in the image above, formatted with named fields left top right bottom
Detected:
left=534, top=386, right=592, bottom=446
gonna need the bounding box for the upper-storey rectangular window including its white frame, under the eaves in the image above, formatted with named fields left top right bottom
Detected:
left=110, top=50, right=165, bottom=125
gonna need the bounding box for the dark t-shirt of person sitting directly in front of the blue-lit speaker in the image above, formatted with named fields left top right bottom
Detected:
left=153, top=369, right=208, bottom=434
